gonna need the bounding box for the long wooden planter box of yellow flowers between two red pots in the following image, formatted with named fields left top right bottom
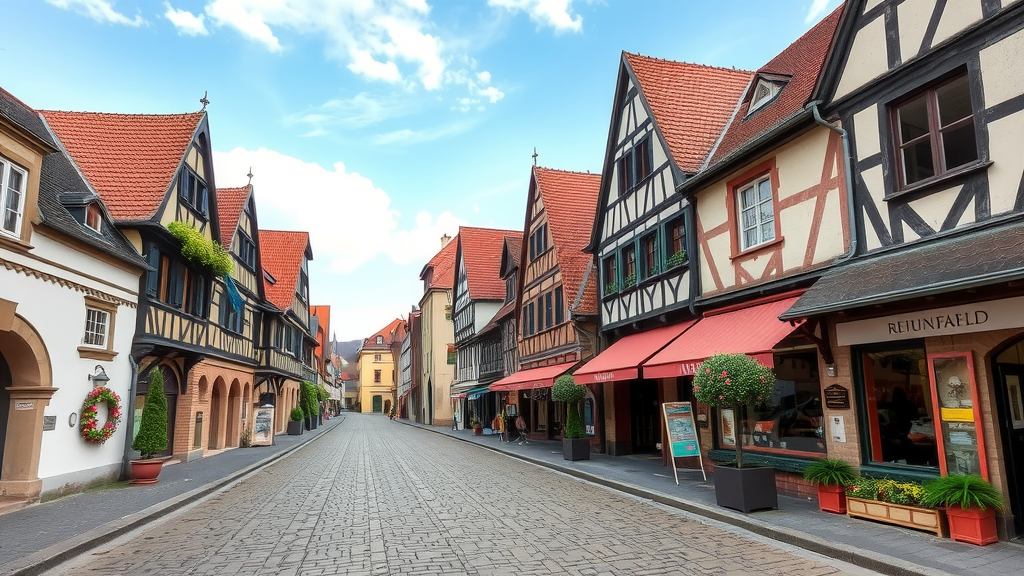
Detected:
left=846, top=478, right=946, bottom=536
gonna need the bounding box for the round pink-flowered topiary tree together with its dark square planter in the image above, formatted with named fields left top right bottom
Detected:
left=693, top=354, right=778, bottom=512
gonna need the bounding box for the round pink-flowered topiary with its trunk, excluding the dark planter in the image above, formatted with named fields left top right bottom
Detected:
left=693, top=354, right=775, bottom=468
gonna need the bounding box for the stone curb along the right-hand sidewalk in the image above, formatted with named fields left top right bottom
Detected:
left=402, top=421, right=954, bottom=576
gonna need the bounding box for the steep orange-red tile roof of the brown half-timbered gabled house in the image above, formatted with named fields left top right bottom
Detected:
left=536, top=166, right=601, bottom=314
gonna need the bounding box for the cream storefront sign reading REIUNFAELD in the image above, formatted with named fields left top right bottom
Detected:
left=836, top=296, right=1024, bottom=346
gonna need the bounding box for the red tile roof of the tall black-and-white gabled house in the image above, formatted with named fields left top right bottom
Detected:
left=623, top=52, right=752, bottom=172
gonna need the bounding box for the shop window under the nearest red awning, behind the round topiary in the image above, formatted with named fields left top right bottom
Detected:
left=718, top=349, right=825, bottom=454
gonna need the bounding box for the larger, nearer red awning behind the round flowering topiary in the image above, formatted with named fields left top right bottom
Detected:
left=638, top=296, right=800, bottom=378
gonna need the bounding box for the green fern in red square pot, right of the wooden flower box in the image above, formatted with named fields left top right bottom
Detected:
left=921, top=475, right=1002, bottom=546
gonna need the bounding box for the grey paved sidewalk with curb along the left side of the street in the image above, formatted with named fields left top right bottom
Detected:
left=0, top=415, right=345, bottom=576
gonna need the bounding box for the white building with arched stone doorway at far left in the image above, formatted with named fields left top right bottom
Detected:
left=0, top=89, right=146, bottom=500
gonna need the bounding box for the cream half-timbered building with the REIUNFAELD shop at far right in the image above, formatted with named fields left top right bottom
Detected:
left=783, top=0, right=1024, bottom=538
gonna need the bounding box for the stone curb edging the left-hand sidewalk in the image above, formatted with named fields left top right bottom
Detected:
left=0, top=418, right=345, bottom=576
